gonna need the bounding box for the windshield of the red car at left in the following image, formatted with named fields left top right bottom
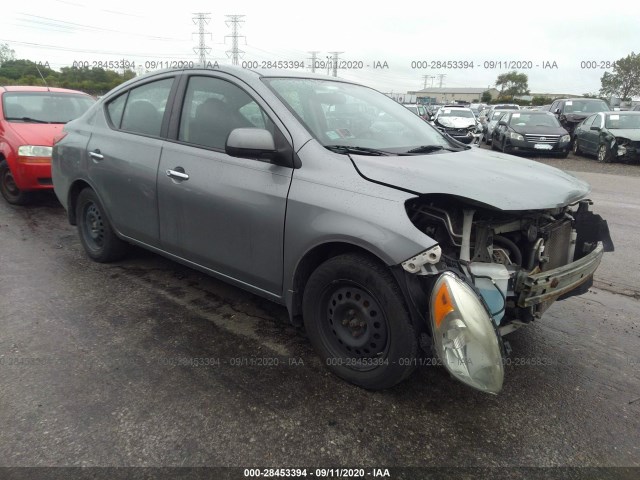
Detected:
left=2, top=92, right=95, bottom=123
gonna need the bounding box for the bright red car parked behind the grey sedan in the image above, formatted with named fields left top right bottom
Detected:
left=0, top=86, right=95, bottom=205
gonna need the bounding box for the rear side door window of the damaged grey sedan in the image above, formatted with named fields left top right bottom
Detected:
left=115, top=78, right=173, bottom=137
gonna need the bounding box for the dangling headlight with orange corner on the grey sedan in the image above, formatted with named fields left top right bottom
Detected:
left=431, top=272, right=504, bottom=394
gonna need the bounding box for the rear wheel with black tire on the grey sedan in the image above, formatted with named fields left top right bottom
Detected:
left=76, top=188, right=128, bottom=263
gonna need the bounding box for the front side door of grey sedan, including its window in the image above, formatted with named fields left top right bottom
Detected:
left=158, top=72, right=292, bottom=296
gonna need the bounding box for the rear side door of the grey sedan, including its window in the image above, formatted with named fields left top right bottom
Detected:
left=87, top=76, right=175, bottom=246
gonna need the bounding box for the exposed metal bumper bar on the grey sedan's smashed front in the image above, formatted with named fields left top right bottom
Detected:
left=517, top=242, right=605, bottom=307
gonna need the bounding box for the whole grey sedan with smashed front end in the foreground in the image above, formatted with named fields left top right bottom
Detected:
left=52, top=67, right=613, bottom=393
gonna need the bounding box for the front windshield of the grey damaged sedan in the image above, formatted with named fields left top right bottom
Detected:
left=263, top=78, right=452, bottom=153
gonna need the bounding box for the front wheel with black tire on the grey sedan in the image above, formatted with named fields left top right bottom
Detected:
left=303, top=254, right=418, bottom=390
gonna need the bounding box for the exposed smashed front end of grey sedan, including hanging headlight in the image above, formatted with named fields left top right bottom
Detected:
left=402, top=194, right=613, bottom=394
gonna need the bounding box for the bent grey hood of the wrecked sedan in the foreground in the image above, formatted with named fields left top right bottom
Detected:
left=351, top=148, right=591, bottom=210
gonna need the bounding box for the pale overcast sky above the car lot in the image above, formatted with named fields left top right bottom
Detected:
left=0, top=0, right=640, bottom=95
